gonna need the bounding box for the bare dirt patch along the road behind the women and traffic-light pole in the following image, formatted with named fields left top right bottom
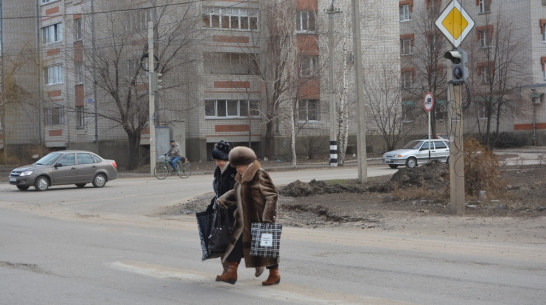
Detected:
left=161, top=163, right=546, bottom=230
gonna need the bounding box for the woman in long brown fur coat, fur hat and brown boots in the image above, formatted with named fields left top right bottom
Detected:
left=216, top=146, right=281, bottom=286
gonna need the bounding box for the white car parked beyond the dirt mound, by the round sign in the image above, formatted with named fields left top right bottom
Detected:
left=382, top=139, right=449, bottom=168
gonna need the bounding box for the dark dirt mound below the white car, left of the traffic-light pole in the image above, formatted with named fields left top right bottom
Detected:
left=388, top=161, right=449, bottom=190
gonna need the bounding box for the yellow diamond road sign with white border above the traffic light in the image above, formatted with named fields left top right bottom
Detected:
left=435, top=0, right=474, bottom=48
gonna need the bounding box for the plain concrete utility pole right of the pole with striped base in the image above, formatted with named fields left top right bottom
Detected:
left=352, top=0, right=368, bottom=183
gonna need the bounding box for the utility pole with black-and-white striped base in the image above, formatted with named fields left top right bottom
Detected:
left=325, top=0, right=341, bottom=167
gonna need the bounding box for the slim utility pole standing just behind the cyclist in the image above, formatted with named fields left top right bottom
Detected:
left=148, top=21, right=156, bottom=175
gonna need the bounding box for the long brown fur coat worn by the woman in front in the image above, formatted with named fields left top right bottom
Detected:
left=218, top=161, right=279, bottom=268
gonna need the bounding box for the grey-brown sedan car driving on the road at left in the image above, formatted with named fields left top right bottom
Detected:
left=9, top=150, right=118, bottom=191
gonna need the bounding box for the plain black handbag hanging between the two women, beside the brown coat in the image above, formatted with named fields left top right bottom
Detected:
left=207, top=206, right=232, bottom=257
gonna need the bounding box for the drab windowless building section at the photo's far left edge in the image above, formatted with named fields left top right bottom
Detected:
left=0, top=1, right=43, bottom=149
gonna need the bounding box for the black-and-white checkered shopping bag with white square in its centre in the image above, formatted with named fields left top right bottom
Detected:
left=250, top=222, right=282, bottom=257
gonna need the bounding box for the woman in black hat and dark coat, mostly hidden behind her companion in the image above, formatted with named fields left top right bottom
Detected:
left=207, top=141, right=237, bottom=274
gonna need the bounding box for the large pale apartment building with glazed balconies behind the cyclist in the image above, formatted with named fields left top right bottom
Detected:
left=2, top=0, right=399, bottom=164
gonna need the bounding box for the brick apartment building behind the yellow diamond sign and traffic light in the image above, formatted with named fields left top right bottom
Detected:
left=399, top=0, right=546, bottom=144
